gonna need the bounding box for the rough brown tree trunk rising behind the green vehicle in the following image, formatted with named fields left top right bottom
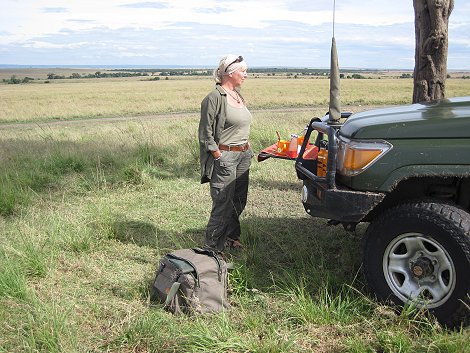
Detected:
left=413, top=0, right=454, bottom=103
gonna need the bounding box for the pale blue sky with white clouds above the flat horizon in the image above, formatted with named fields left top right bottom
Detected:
left=0, top=0, right=470, bottom=70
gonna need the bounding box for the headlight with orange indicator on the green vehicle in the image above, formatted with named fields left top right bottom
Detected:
left=336, top=136, right=393, bottom=176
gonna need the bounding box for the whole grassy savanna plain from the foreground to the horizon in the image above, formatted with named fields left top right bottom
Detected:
left=0, top=72, right=470, bottom=353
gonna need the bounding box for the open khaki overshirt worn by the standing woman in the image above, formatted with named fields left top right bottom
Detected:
left=198, top=84, right=243, bottom=184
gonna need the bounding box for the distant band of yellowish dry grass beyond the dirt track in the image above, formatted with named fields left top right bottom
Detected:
left=0, top=77, right=470, bottom=124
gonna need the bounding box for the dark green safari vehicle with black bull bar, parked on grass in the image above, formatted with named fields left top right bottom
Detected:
left=295, top=97, right=470, bottom=327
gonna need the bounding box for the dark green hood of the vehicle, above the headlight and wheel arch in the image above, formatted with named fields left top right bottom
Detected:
left=339, top=97, right=470, bottom=140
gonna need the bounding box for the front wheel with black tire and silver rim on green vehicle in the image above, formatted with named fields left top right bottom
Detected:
left=363, top=200, right=470, bottom=327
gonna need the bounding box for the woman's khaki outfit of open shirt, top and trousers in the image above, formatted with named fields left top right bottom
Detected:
left=198, top=84, right=253, bottom=251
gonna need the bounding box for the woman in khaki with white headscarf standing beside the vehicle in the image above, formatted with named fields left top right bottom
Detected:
left=199, top=55, right=253, bottom=252
